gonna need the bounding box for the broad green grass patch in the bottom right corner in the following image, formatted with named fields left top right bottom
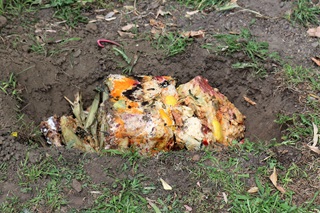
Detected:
left=186, top=149, right=319, bottom=213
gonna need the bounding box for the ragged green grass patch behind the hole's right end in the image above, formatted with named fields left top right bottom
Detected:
left=206, top=29, right=280, bottom=77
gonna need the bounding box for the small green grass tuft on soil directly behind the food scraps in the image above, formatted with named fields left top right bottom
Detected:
left=152, top=32, right=193, bottom=57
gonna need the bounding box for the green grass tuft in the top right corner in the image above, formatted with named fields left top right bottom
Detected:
left=287, top=0, right=320, bottom=27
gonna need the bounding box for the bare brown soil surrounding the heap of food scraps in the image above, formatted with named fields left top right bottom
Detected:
left=0, top=0, right=320, bottom=212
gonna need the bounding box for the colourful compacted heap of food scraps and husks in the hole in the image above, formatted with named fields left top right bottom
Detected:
left=40, top=74, right=245, bottom=154
